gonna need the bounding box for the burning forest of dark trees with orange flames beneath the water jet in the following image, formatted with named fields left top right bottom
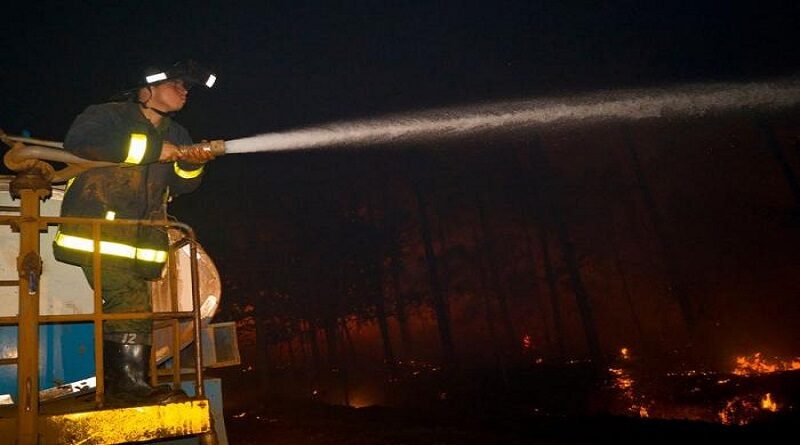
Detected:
left=172, top=103, right=800, bottom=440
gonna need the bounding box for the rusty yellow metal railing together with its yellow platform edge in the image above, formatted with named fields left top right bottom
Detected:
left=0, top=164, right=216, bottom=445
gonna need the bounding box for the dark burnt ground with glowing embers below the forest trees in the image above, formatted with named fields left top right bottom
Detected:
left=212, top=362, right=800, bottom=445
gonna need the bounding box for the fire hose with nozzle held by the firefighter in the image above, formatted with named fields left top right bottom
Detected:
left=0, top=130, right=225, bottom=183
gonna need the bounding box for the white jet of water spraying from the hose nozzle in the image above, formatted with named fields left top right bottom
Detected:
left=225, top=78, right=800, bottom=154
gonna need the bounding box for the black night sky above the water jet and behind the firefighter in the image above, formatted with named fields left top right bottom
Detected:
left=0, top=0, right=800, bottom=360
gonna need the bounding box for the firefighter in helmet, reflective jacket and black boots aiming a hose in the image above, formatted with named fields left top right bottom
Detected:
left=53, top=61, right=216, bottom=404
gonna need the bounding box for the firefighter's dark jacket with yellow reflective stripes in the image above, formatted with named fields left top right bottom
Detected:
left=53, top=102, right=203, bottom=279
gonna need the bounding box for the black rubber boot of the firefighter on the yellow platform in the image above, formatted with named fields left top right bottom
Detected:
left=103, top=341, right=187, bottom=405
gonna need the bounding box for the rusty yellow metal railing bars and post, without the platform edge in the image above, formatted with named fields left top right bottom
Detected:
left=0, top=177, right=205, bottom=444
